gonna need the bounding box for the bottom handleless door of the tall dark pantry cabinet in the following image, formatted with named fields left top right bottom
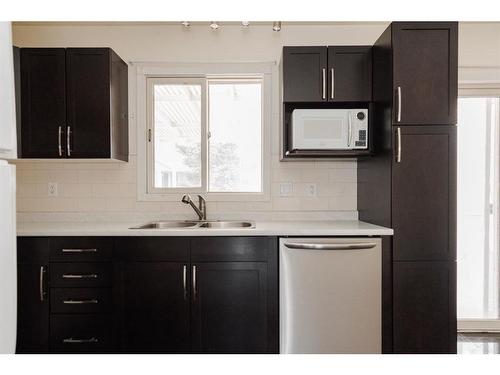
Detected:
left=393, top=262, right=457, bottom=354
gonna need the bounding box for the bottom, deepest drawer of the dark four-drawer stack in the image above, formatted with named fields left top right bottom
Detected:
left=50, top=315, right=113, bottom=353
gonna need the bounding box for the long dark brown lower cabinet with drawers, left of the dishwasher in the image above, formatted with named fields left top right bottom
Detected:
left=17, top=237, right=279, bottom=353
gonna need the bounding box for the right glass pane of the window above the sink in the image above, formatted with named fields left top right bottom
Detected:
left=208, top=80, right=262, bottom=192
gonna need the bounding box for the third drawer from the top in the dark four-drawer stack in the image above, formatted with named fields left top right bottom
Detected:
left=50, top=288, right=111, bottom=314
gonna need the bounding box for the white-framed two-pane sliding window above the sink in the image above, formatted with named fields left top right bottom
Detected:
left=146, top=76, right=264, bottom=194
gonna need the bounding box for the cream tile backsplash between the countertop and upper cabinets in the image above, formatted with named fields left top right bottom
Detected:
left=16, top=155, right=357, bottom=221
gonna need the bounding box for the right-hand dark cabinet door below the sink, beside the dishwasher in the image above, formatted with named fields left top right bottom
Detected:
left=191, top=262, right=269, bottom=353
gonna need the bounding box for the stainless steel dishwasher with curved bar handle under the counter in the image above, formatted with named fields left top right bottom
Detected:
left=279, top=237, right=382, bottom=353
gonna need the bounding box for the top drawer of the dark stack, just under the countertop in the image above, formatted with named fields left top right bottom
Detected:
left=50, top=237, right=113, bottom=262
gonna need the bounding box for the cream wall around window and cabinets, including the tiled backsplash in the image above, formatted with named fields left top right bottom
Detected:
left=13, top=22, right=500, bottom=220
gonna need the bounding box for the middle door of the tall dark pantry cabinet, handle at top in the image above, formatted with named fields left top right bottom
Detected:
left=392, top=126, right=457, bottom=261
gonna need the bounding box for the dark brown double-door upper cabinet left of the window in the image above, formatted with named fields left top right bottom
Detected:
left=19, top=48, right=128, bottom=161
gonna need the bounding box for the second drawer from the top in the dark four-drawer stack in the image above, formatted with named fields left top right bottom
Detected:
left=50, top=263, right=112, bottom=287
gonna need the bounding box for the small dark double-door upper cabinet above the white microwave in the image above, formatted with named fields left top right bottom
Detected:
left=282, top=46, right=372, bottom=103
